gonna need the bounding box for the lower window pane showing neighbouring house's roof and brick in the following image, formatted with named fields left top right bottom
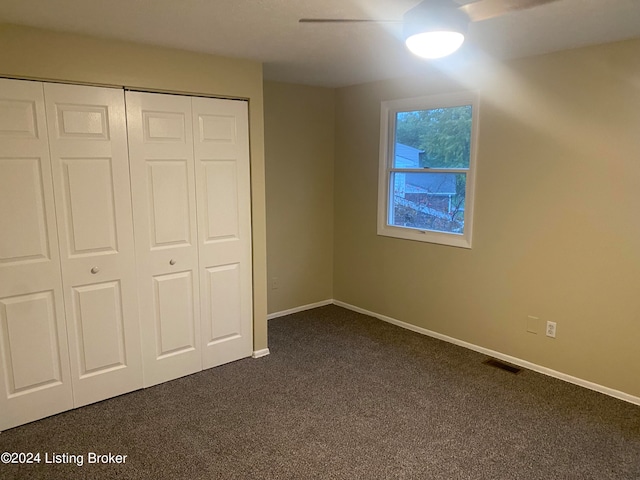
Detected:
left=389, top=172, right=467, bottom=234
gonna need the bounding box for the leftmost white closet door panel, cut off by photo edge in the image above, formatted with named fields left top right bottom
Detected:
left=0, top=79, right=73, bottom=430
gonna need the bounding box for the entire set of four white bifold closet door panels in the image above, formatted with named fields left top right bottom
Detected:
left=0, top=79, right=253, bottom=430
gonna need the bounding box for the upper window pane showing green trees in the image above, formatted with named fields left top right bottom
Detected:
left=393, top=105, right=471, bottom=168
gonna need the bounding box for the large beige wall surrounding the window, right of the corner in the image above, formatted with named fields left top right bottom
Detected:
left=334, top=40, right=640, bottom=396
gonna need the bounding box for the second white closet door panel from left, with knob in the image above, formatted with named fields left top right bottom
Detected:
left=45, top=84, right=142, bottom=406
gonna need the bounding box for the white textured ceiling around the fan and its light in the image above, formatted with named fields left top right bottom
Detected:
left=0, top=0, right=640, bottom=86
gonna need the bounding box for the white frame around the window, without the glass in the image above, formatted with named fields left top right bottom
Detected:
left=378, top=92, right=479, bottom=248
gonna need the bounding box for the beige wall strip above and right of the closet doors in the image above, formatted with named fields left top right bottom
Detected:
left=0, top=24, right=267, bottom=350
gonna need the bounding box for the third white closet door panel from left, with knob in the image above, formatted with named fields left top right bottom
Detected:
left=126, top=92, right=202, bottom=386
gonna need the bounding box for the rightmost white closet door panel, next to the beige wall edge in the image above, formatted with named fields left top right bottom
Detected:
left=192, top=98, right=253, bottom=368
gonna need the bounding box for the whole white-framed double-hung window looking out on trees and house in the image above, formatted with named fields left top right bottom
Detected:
left=378, top=93, right=478, bottom=248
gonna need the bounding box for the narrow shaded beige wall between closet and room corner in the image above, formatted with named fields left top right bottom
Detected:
left=264, top=82, right=335, bottom=313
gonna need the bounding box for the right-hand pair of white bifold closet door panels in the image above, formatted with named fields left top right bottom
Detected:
left=126, top=92, right=252, bottom=386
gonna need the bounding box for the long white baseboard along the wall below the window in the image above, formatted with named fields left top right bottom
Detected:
left=333, top=300, right=640, bottom=405
